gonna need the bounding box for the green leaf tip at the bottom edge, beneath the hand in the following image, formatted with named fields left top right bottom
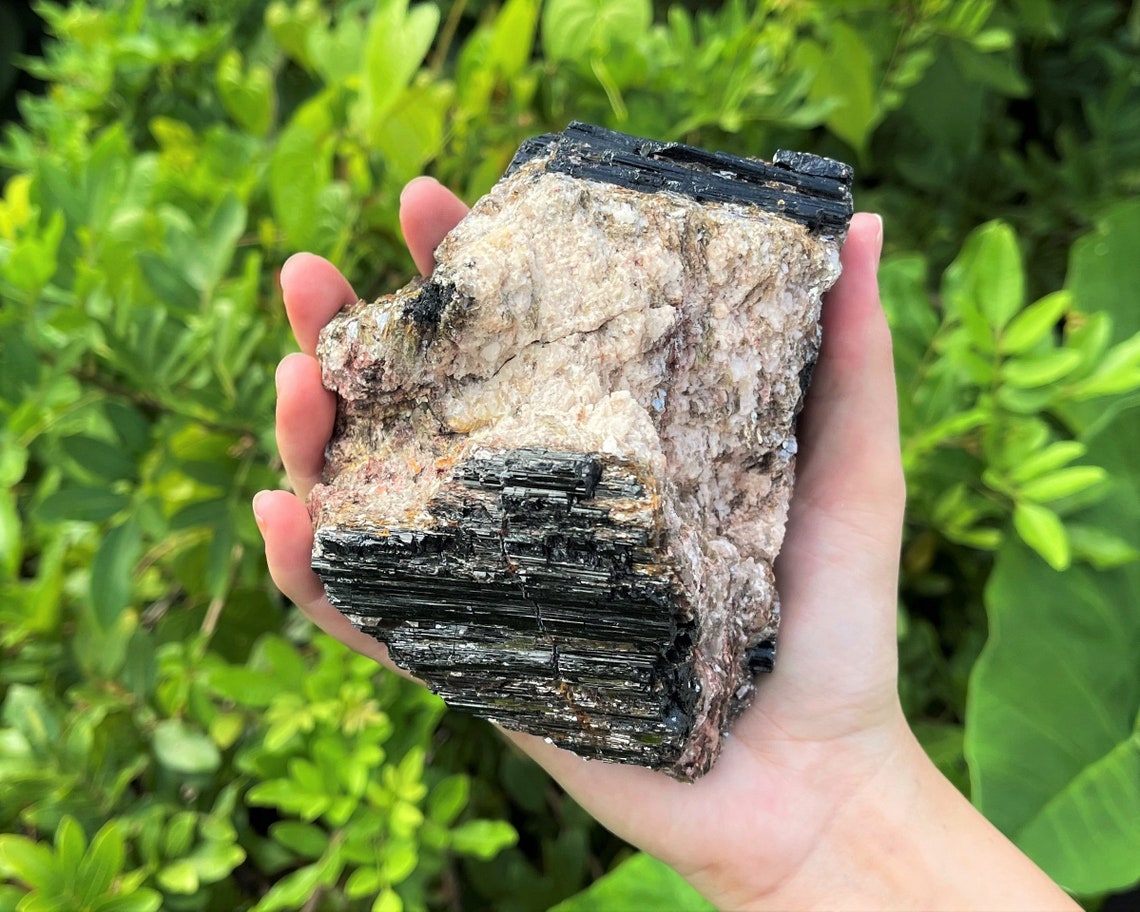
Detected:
left=549, top=853, right=713, bottom=912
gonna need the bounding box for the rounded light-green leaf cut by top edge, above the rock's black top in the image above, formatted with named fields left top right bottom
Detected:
left=543, top=0, right=653, bottom=63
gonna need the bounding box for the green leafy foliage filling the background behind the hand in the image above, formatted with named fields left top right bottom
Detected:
left=0, top=0, right=1140, bottom=912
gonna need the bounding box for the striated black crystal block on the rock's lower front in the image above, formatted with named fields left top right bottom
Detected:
left=314, top=447, right=702, bottom=766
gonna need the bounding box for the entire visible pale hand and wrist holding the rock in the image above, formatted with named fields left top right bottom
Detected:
left=254, top=178, right=1078, bottom=910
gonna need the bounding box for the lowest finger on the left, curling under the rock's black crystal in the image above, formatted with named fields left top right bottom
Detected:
left=253, top=491, right=388, bottom=665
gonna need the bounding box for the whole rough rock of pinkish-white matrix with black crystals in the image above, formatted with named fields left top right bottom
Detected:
left=310, top=124, right=852, bottom=780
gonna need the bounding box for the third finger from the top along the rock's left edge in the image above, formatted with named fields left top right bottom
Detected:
left=277, top=353, right=336, bottom=500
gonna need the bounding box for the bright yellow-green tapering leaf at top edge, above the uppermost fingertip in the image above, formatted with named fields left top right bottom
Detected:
left=360, top=0, right=439, bottom=140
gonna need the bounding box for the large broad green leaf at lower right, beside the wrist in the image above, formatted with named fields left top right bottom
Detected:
left=966, top=543, right=1140, bottom=895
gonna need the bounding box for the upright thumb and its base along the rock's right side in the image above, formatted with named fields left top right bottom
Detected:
left=752, top=214, right=906, bottom=740
